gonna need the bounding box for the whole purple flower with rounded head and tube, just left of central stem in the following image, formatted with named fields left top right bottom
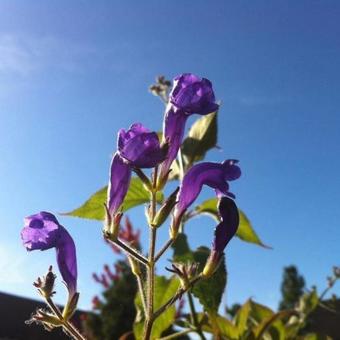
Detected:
left=107, top=123, right=167, bottom=216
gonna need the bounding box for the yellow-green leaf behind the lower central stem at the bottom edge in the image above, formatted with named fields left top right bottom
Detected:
left=133, top=276, right=179, bottom=340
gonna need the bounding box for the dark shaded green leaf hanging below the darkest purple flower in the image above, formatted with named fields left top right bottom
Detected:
left=192, top=247, right=227, bottom=315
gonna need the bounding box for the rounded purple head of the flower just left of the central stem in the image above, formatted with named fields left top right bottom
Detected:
left=118, top=123, right=166, bottom=168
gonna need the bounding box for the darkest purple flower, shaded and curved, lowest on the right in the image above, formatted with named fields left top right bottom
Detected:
left=203, top=196, right=239, bottom=277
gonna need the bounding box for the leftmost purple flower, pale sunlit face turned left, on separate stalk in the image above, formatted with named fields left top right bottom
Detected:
left=21, top=211, right=77, bottom=296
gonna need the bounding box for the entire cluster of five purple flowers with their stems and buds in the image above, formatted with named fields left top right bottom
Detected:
left=21, top=73, right=241, bottom=339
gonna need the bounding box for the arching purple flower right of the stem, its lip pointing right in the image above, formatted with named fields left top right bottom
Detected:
left=171, top=159, right=241, bottom=237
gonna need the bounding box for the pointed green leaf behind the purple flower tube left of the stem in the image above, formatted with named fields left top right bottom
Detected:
left=62, top=177, right=163, bottom=221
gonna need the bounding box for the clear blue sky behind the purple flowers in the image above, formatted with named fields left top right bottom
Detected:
left=0, top=0, right=340, bottom=308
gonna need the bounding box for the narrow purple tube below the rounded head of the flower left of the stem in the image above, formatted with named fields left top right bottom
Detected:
left=107, top=153, right=131, bottom=217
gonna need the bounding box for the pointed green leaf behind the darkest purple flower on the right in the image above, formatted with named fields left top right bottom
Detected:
left=195, top=198, right=270, bottom=248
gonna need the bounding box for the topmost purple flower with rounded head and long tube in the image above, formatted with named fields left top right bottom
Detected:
left=160, top=73, right=219, bottom=182
